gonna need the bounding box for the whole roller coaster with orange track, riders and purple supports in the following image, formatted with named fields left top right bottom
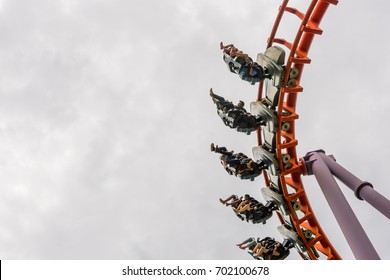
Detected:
left=210, top=0, right=390, bottom=260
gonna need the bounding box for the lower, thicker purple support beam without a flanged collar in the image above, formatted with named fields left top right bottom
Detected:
left=303, top=151, right=380, bottom=260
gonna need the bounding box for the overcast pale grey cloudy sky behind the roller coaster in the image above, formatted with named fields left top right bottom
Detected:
left=0, top=0, right=390, bottom=259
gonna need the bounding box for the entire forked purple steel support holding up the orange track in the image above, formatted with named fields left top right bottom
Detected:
left=303, top=150, right=390, bottom=260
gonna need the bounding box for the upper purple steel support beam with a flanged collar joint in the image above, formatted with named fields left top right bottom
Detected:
left=319, top=153, right=390, bottom=219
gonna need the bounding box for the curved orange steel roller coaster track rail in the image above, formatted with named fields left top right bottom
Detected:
left=257, top=0, right=341, bottom=259
